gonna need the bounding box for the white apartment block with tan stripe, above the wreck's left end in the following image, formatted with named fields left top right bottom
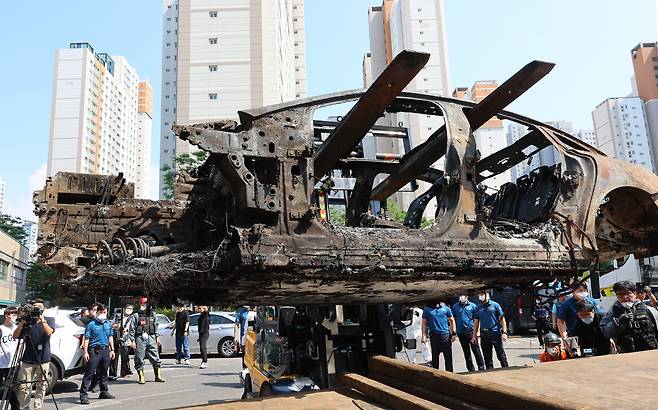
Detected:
left=47, top=43, right=151, bottom=194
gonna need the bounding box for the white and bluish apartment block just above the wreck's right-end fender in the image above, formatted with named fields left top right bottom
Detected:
left=592, top=97, right=656, bottom=172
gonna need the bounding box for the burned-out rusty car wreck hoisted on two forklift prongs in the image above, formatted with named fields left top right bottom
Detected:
left=34, top=51, right=658, bottom=304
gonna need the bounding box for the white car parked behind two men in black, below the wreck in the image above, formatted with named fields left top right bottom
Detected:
left=158, top=312, right=238, bottom=357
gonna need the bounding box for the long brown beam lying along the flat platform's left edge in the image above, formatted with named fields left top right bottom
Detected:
left=368, top=356, right=587, bottom=410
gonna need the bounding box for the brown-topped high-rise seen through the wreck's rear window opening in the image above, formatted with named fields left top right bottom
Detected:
left=452, top=80, right=512, bottom=193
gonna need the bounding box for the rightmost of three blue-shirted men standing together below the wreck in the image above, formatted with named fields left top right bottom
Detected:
left=472, top=291, right=508, bottom=369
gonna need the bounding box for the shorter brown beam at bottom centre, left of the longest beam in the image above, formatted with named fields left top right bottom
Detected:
left=337, top=373, right=447, bottom=410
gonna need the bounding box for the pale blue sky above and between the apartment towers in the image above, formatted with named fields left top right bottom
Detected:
left=0, top=0, right=656, bottom=220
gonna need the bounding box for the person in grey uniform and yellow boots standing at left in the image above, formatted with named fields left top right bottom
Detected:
left=130, top=296, right=164, bottom=384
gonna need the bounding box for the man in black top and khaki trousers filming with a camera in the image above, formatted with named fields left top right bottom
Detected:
left=13, top=299, right=55, bottom=410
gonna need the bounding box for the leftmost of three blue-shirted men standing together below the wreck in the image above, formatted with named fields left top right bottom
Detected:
left=421, top=302, right=455, bottom=372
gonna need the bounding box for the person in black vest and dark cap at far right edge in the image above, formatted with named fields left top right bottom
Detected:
left=600, top=280, right=658, bottom=353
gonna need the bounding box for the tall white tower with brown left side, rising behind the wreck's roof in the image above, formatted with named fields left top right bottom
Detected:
left=363, top=0, right=450, bottom=217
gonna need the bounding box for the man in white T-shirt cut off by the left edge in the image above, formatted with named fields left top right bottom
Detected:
left=0, top=307, right=18, bottom=410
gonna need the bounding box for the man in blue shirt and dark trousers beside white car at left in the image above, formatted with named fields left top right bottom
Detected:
left=80, top=304, right=115, bottom=404
